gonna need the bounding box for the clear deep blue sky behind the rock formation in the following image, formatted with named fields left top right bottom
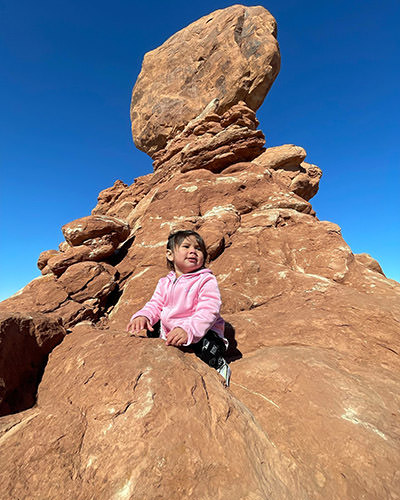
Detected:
left=0, top=0, right=400, bottom=299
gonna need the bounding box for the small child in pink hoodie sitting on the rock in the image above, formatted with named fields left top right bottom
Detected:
left=127, top=231, right=231, bottom=385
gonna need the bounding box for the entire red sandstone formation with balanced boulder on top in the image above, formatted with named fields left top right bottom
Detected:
left=0, top=5, right=400, bottom=500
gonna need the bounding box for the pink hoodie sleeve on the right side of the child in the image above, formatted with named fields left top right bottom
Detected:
left=176, top=274, right=221, bottom=345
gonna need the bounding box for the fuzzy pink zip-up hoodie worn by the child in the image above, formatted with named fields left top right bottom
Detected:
left=131, top=269, right=225, bottom=345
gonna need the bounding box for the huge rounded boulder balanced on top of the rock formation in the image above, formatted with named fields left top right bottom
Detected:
left=131, top=5, right=280, bottom=156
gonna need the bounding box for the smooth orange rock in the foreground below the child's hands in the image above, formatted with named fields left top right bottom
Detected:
left=0, top=325, right=306, bottom=500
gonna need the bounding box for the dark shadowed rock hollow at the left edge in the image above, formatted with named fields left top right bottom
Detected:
left=0, top=312, right=66, bottom=416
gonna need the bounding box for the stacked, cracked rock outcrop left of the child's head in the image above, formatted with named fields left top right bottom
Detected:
left=1, top=215, right=130, bottom=327
